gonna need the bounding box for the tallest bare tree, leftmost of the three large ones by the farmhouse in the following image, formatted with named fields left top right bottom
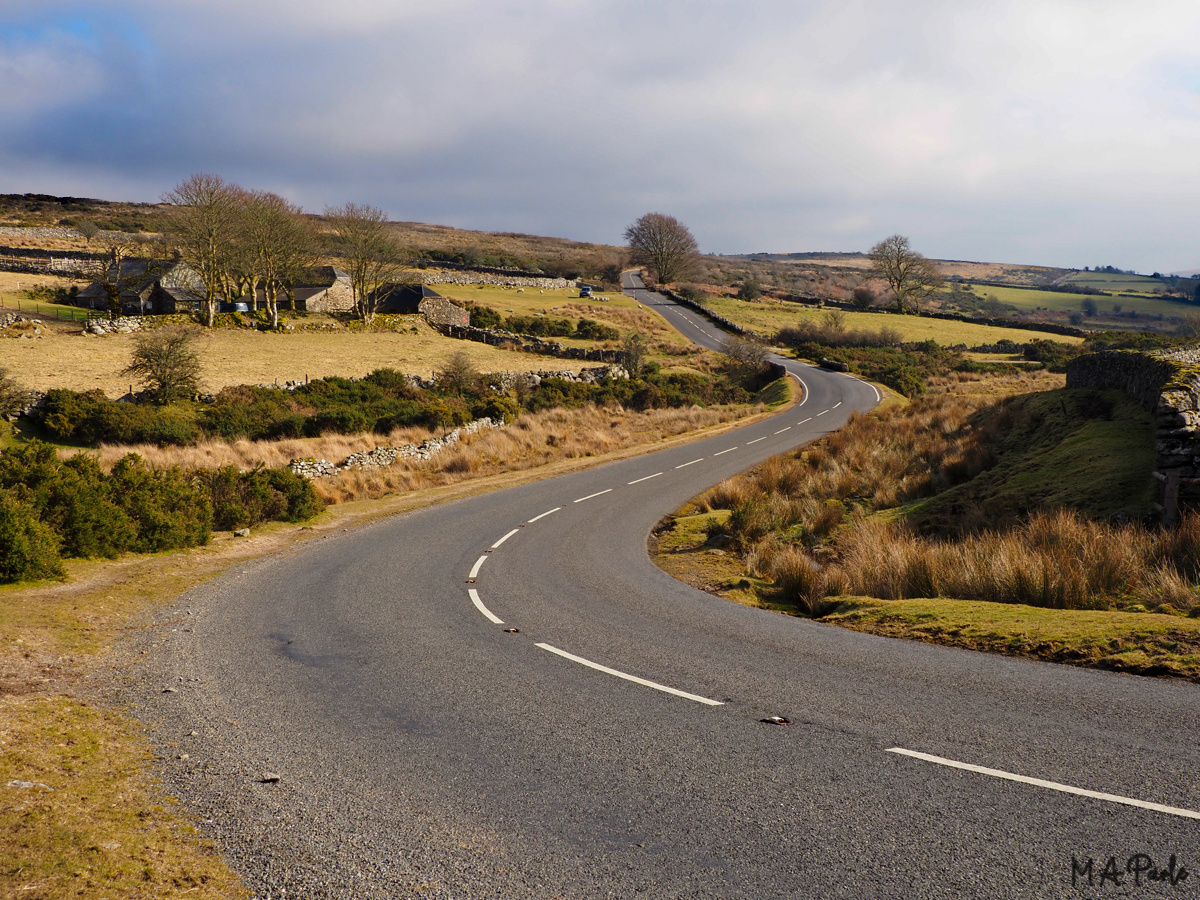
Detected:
left=162, top=173, right=245, bottom=326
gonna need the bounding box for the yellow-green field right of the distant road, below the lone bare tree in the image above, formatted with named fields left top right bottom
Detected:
left=706, top=298, right=1082, bottom=346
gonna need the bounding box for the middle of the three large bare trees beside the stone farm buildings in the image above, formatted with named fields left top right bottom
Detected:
left=241, top=191, right=316, bottom=328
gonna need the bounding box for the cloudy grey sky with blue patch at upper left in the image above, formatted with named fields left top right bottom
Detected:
left=0, top=0, right=1200, bottom=274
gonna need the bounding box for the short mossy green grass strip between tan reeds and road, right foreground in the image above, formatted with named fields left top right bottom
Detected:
left=821, top=598, right=1200, bottom=682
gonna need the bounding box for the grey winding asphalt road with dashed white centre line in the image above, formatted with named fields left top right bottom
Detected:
left=134, top=278, right=1200, bottom=900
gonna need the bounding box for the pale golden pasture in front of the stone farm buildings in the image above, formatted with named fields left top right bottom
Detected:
left=0, top=324, right=581, bottom=397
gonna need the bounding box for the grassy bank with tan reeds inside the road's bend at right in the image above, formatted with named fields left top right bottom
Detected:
left=652, top=379, right=1200, bottom=680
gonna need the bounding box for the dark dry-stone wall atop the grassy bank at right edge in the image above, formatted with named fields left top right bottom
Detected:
left=1067, top=349, right=1200, bottom=524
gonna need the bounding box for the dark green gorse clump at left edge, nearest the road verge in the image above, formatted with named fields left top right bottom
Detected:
left=0, top=442, right=324, bottom=581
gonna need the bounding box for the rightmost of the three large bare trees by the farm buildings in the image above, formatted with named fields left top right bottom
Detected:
left=325, top=203, right=406, bottom=324
